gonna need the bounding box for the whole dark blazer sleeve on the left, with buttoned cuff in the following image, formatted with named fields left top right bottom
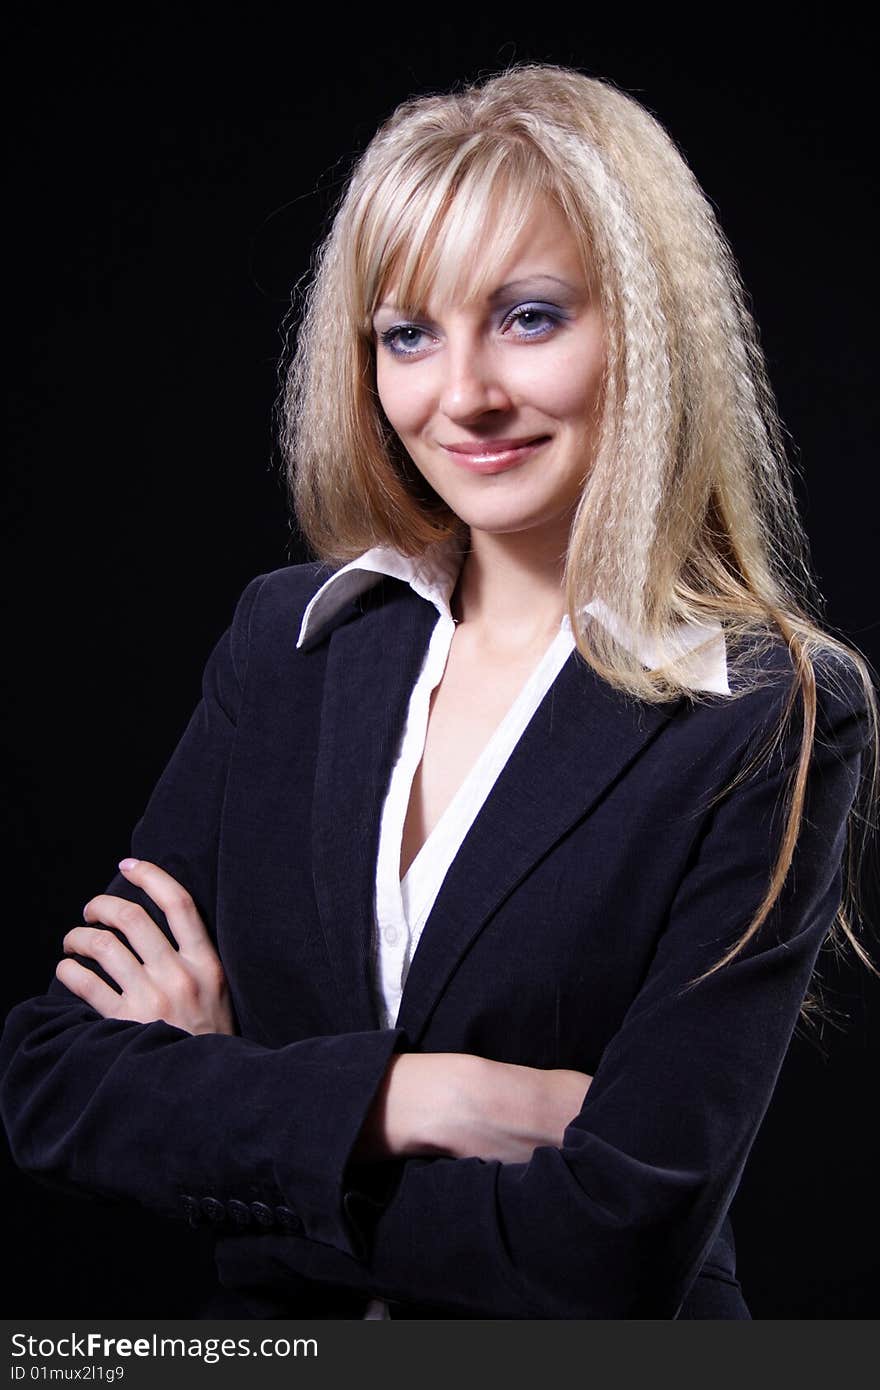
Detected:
left=0, top=575, right=403, bottom=1254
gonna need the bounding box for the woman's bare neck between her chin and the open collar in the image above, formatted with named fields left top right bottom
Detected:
left=453, top=528, right=567, bottom=648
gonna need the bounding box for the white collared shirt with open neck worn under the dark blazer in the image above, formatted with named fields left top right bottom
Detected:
left=296, top=545, right=730, bottom=1318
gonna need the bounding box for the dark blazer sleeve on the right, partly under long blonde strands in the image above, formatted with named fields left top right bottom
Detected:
left=218, top=650, right=869, bottom=1319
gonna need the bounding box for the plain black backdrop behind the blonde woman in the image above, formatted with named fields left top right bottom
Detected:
left=6, top=6, right=880, bottom=1318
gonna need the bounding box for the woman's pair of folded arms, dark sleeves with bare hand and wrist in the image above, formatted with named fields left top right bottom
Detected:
left=0, top=578, right=867, bottom=1318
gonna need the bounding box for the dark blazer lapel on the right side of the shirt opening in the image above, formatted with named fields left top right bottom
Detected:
left=398, top=652, right=683, bottom=1045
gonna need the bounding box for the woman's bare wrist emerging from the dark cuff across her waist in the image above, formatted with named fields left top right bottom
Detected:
left=352, top=1052, right=592, bottom=1163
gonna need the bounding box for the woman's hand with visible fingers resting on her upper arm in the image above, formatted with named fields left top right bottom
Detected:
left=56, top=859, right=235, bottom=1034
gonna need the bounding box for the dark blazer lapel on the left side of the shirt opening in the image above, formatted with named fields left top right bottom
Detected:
left=311, top=580, right=438, bottom=1033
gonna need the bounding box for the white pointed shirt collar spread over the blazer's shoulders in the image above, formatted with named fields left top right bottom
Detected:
left=296, top=542, right=730, bottom=695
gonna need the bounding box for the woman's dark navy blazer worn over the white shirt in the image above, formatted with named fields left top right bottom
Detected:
left=0, top=564, right=867, bottom=1318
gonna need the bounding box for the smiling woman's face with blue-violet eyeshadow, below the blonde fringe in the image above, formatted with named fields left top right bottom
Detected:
left=373, top=202, right=605, bottom=534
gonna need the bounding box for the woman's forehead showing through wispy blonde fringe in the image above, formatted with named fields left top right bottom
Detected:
left=377, top=195, right=585, bottom=310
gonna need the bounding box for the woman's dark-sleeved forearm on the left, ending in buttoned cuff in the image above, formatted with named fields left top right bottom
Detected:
left=0, top=986, right=406, bottom=1251
